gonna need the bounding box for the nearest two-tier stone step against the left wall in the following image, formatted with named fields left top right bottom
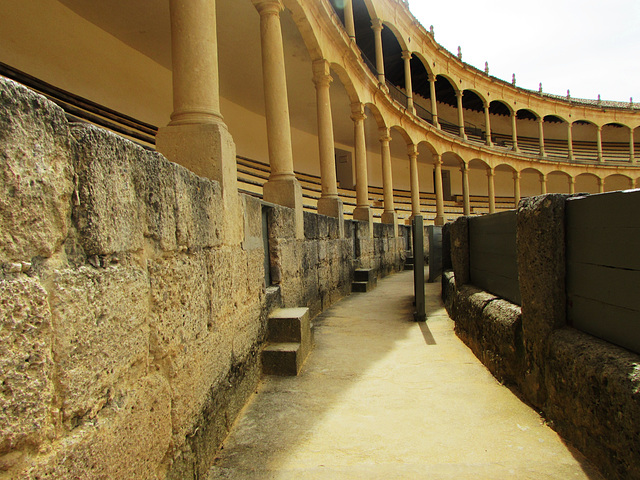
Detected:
left=262, top=307, right=313, bottom=375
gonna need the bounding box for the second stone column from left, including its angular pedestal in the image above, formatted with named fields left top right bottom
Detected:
left=252, top=0, right=304, bottom=238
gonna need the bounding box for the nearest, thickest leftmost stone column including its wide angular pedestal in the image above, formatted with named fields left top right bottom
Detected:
left=156, top=0, right=240, bottom=242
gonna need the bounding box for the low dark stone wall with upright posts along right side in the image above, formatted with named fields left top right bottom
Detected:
left=442, top=195, right=640, bottom=479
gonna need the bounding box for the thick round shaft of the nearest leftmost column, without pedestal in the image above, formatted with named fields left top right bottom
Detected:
left=169, top=0, right=222, bottom=125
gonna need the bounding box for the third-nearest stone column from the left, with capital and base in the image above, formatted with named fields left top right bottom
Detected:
left=313, top=60, right=342, bottom=219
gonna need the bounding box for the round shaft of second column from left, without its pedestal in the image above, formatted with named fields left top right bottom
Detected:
left=253, top=0, right=295, bottom=181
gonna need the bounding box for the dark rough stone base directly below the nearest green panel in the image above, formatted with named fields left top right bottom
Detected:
left=545, top=328, right=640, bottom=480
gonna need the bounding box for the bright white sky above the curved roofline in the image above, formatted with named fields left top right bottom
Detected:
left=409, top=0, right=640, bottom=103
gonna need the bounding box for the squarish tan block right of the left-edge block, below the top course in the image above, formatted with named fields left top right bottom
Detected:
left=49, top=266, right=149, bottom=428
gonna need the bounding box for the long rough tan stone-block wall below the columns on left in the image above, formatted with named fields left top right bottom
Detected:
left=0, top=80, right=403, bottom=479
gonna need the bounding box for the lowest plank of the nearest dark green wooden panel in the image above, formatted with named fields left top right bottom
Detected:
left=567, top=295, right=640, bottom=353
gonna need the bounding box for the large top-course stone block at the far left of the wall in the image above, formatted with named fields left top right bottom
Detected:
left=0, top=79, right=73, bottom=262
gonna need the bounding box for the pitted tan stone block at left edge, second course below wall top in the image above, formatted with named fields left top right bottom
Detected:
left=0, top=275, right=54, bottom=455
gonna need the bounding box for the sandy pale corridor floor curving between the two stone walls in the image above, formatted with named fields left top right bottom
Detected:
left=209, top=272, right=602, bottom=480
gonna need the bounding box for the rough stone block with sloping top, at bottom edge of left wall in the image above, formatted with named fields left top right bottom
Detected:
left=20, top=374, right=171, bottom=480
